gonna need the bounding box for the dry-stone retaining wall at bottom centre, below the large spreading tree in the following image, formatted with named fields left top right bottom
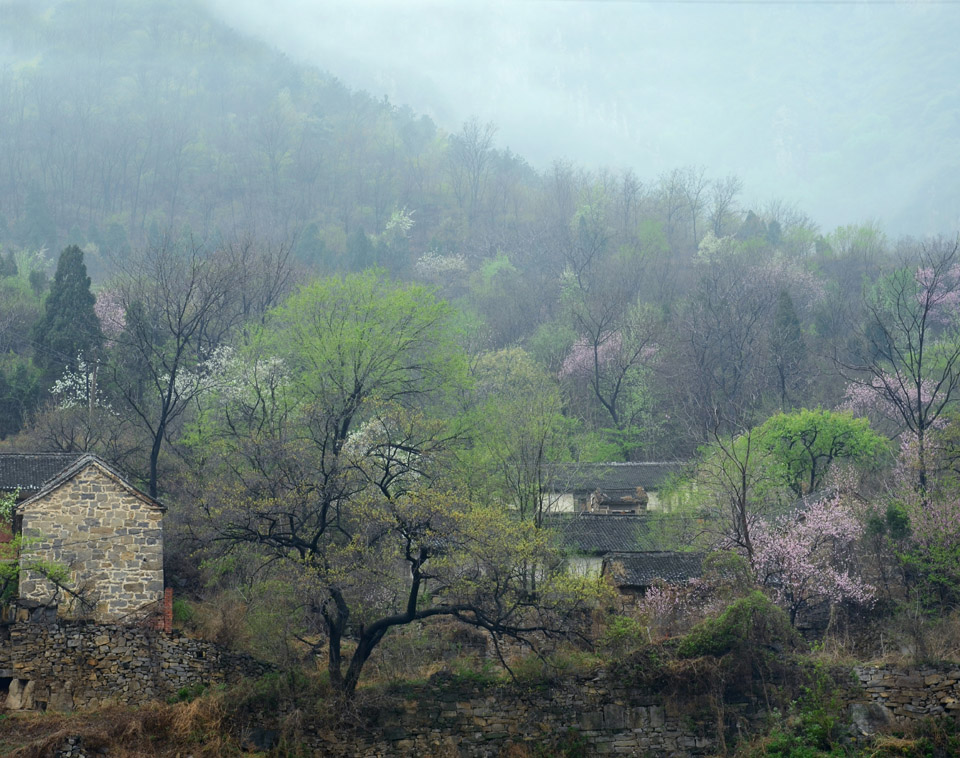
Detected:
left=304, top=673, right=717, bottom=758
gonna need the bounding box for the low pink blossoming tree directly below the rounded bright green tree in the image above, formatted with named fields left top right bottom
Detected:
left=753, top=495, right=874, bottom=623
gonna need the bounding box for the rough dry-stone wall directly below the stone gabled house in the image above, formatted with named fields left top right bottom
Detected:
left=0, top=622, right=269, bottom=710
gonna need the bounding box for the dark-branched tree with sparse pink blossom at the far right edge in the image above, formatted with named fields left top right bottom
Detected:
left=839, top=239, right=960, bottom=493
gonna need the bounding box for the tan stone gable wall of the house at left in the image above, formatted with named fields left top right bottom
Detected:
left=20, top=465, right=163, bottom=623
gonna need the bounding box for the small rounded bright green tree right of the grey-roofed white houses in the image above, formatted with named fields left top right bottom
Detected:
left=756, top=408, right=888, bottom=497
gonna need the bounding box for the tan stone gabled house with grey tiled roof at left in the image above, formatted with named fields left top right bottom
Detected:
left=0, top=453, right=165, bottom=624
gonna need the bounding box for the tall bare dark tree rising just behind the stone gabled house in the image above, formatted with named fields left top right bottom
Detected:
left=107, top=240, right=290, bottom=497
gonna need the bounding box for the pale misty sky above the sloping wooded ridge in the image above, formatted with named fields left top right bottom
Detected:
left=207, top=0, right=960, bottom=234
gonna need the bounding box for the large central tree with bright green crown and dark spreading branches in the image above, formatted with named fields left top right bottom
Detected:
left=196, top=271, right=587, bottom=695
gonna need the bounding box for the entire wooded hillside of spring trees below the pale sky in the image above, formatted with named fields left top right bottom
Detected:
left=0, top=0, right=960, bottom=756
